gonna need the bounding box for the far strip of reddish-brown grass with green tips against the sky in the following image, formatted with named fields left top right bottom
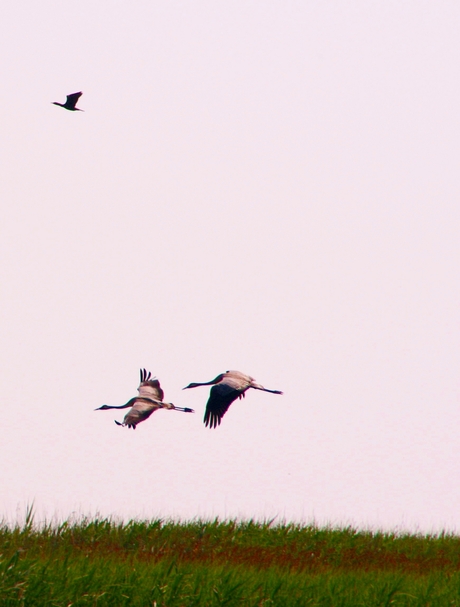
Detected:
left=0, top=519, right=460, bottom=575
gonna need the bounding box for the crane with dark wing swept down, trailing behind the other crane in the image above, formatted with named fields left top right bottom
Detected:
left=183, top=371, right=283, bottom=428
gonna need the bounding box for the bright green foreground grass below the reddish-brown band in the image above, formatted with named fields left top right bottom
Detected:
left=0, top=552, right=460, bottom=607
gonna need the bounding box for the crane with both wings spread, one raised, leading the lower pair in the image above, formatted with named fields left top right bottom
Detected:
left=95, top=369, right=195, bottom=430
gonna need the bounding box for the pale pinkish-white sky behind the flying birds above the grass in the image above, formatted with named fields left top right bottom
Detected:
left=0, top=0, right=460, bottom=532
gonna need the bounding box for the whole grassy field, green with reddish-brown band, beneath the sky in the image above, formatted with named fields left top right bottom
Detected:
left=0, top=511, right=460, bottom=607
